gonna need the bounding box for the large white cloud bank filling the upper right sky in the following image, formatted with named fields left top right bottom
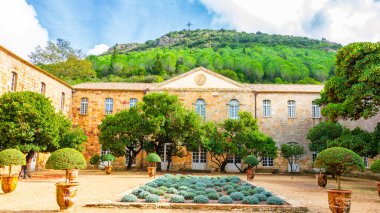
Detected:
left=200, top=0, right=380, bottom=44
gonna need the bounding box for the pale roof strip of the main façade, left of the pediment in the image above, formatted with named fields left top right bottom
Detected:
left=73, top=82, right=156, bottom=91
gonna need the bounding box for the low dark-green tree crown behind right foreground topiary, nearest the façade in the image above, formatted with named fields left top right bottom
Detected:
left=306, top=121, right=344, bottom=152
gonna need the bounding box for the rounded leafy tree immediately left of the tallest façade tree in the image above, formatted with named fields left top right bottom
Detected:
left=99, top=107, right=149, bottom=170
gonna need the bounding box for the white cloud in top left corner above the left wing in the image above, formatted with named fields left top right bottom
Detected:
left=0, top=0, right=49, bottom=59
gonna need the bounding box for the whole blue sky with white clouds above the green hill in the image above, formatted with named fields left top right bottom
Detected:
left=0, top=0, right=380, bottom=59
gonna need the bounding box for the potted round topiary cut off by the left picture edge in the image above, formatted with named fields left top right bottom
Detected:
left=0, top=149, right=26, bottom=193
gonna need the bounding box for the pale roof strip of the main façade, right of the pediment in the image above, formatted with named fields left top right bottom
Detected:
left=246, top=84, right=324, bottom=93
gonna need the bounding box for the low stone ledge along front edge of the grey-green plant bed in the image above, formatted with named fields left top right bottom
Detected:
left=85, top=201, right=308, bottom=213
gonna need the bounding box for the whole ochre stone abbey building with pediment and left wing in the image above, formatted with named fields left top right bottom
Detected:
left=0, top=46, right=380, bottom=172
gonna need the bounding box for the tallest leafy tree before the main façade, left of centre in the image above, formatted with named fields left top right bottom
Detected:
left=141, top=93, right=202, bottom=169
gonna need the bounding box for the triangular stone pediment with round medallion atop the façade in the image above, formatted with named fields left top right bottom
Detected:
left=150, top=67, right=249, bottom=90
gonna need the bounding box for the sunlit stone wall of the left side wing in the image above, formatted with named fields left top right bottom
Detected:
left=0, top=46, right=72, bottom=116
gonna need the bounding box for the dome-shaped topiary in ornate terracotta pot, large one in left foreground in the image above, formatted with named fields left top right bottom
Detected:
left=46, top=148, right=86, bottom=210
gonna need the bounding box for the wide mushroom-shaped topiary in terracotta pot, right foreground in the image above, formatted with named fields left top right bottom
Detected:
left=315, top=147, right=365, bottom=213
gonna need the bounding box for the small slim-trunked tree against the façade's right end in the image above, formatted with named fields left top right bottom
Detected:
left=280, top=142, right=305, bottom=173
